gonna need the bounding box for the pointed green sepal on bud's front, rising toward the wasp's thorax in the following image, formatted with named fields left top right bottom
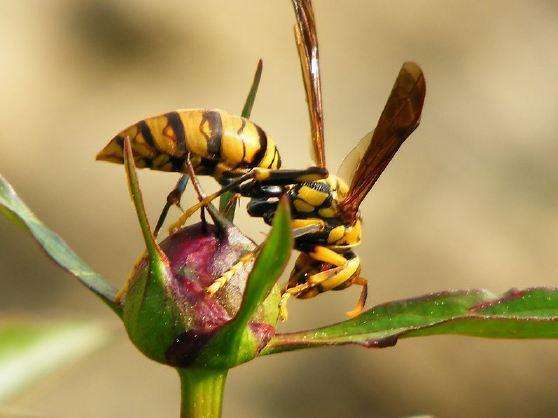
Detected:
left=197, top=198, right=293, bottom=368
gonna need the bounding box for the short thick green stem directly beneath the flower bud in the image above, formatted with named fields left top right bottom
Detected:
left=177, top=369, right=228, bottom=418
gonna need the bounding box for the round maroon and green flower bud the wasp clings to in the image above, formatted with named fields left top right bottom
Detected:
left=121, top=223, right=279, bottom=367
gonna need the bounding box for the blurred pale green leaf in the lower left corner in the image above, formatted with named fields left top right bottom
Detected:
left=0, top=321, right=110, bottom=403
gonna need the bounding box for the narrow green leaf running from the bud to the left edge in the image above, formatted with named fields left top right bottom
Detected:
left=0, top=175, right=120, bottom=314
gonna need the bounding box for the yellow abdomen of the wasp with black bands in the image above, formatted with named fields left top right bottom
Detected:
left=97, top=109, right=281, bottom=179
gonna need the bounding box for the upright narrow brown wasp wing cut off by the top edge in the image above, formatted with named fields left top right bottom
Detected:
left=292, top=0, right=326, bottom=168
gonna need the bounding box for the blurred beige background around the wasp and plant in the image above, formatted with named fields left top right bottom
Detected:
left=0, top=0, right=558, bottom=418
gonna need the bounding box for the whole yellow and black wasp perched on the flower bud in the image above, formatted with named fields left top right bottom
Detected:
left=97, top=0, right=426, bottom=317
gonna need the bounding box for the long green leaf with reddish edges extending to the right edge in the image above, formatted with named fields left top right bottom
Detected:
left=264, top=288, right=558, bottom=354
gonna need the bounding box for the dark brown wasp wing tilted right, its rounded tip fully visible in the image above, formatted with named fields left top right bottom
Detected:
left=339, top=62, right=426, bottom=223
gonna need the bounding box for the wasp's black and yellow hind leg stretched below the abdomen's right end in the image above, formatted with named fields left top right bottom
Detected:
left=169, top=167, right=327, bottom=233
